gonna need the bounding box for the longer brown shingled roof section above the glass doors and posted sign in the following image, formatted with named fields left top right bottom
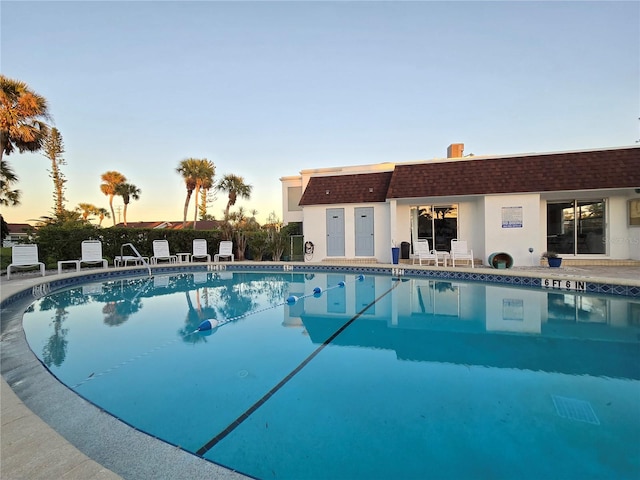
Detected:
left=384, top=147, right=640, bottom=198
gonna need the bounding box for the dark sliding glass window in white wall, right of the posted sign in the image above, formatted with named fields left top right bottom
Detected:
left=547, top=199, right=606, bottom=255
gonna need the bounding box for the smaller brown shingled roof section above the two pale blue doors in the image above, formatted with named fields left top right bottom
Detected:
left=300, top=172, right=392, bottom=205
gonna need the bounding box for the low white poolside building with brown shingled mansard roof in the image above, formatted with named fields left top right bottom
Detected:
left=280, top=144, right=640, bottom=266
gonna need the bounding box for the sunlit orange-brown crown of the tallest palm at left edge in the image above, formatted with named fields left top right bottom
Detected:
left=0, top=75, right=51, bottom=161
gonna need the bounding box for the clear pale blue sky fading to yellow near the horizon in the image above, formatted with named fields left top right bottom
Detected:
left=0, top=0, right=640, bottom=226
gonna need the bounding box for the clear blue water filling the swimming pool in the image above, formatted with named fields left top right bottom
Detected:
left=23, top=272, right=640, bottom=479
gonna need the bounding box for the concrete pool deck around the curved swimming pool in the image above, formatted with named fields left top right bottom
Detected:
left=0, top=264, right=640, bottom=480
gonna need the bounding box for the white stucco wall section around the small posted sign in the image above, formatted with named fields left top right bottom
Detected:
left=484, top=194, right=546, bottom=266
